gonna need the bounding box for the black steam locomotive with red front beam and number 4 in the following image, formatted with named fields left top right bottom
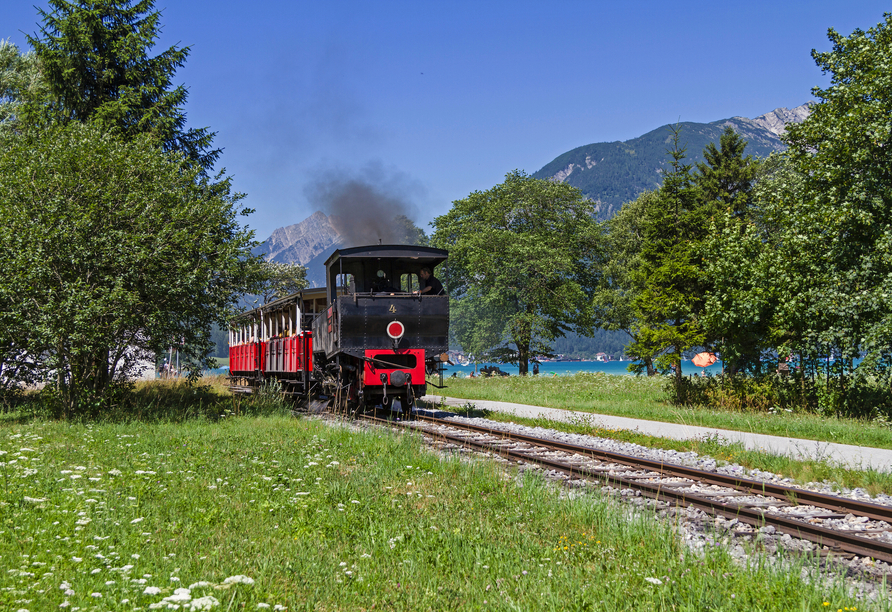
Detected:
left=312, top=245, right=449, bottom=409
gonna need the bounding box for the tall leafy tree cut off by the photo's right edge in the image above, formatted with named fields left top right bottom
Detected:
left=786, top=14, right=892, bottom=378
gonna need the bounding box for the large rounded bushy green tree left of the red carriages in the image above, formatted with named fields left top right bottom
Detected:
left=0, top=122, right=259, bottom=412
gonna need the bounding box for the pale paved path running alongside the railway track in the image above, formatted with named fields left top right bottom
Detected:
left=421, top=395, right=892, bottom=472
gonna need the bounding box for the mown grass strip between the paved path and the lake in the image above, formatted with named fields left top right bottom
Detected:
left=430, top=373, right=892, bottom=448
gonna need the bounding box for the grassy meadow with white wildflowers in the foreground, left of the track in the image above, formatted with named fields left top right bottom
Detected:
left=0, top=383, right=890, bottom=612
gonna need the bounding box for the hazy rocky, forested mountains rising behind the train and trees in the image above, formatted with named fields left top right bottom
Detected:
left=254, top=103, right=811, bottom=286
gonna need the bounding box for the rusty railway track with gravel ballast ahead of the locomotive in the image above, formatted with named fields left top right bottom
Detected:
left=363, top=408, right=892, bottom=564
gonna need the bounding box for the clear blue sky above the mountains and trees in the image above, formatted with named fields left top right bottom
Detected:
left=0, top=0, right=889, bottom=240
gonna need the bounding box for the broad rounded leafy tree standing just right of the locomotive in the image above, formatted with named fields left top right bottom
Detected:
left=431, top=170, right=601, bottom=375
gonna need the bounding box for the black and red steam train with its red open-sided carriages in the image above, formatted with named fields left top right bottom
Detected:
left=229, top=245, right=449, bottom=414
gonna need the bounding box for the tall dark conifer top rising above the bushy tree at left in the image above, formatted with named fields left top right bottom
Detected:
left=28, top=0, right=220, bottom=171
